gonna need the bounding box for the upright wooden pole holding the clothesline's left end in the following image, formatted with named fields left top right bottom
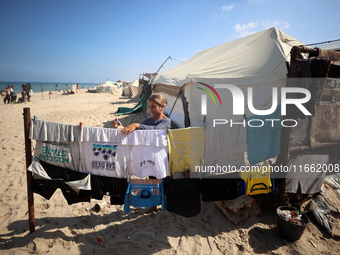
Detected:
left=24, top=107, right=35, bottom=233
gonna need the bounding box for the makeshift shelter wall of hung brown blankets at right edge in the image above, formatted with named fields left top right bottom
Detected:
left=277, top=46, right=340, bottom=197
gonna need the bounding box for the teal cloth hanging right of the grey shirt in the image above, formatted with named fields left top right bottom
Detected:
left=247, top=105, right=281, bottom=165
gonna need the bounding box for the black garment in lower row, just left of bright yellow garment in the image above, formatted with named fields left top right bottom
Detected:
left=201, top=178, right=240, bottom=202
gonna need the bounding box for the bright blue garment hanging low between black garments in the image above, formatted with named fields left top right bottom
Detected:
left=124, top=179, right=166, bottom=213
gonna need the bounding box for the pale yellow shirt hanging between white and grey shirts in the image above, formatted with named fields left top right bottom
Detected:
left=167, top=127, right=205, bottom=177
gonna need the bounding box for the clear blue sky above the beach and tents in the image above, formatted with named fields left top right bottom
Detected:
left=0, top=0, right=340, bottom=82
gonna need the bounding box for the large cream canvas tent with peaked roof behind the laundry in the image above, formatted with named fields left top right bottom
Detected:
left=153, top=27, right=303, bottom=127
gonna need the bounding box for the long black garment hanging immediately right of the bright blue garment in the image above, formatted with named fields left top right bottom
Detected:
left=163, top=178, right=201, bottom=217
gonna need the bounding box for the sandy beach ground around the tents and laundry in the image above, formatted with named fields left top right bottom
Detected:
left=0, top=90, right=340, bottom=254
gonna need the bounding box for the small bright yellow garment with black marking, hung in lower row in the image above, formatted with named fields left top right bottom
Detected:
left=239, top=166, right=272, bottom=196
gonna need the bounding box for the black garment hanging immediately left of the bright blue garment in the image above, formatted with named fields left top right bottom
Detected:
left=91, top=175, right=128, bottom=205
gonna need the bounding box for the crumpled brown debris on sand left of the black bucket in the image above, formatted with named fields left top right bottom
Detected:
left=215, top=195, right=261, bottom=225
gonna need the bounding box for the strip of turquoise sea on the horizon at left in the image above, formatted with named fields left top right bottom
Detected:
left=0, top=81, right=98, bottom=94
